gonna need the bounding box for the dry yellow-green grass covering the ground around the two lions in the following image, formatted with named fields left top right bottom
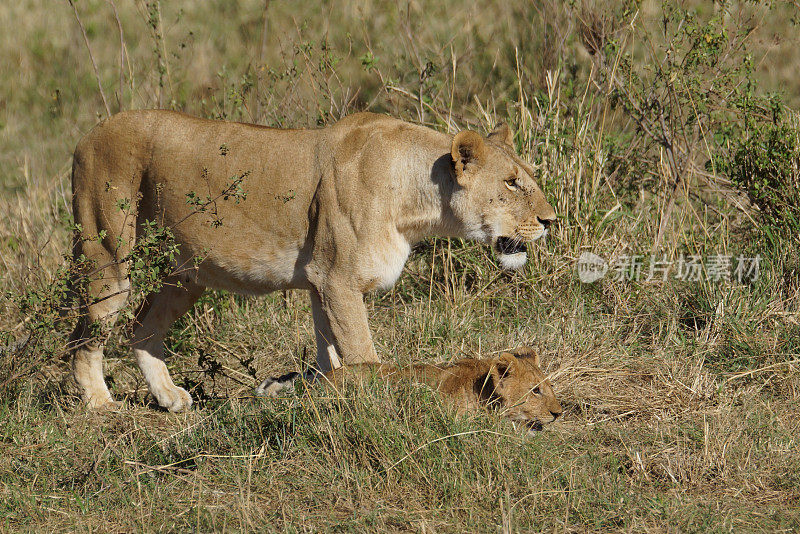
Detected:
left=0, top=1, right=800, bottom=532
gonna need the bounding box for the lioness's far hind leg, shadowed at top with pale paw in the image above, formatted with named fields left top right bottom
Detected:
left=131, top=283, right=204, bottom=412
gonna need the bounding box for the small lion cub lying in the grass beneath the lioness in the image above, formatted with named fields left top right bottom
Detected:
left=256, top=347, right=562, bottom=431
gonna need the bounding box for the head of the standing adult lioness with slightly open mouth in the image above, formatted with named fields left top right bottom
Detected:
left=450, top=124, right=556, bottom=269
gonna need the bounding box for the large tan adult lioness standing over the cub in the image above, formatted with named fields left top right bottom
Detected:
left=72, top=111, right=555, bottom=411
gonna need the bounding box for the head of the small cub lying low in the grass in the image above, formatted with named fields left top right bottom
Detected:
left=479, top=347, right=563, bottom=432
